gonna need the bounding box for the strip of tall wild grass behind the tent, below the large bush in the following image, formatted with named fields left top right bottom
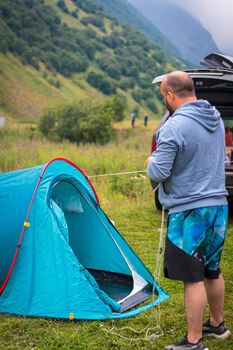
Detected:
left=0, top=121, right=153, bottom=175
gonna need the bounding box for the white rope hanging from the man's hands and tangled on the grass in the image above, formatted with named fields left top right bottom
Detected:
left=100, top=185, right=165, bottom=341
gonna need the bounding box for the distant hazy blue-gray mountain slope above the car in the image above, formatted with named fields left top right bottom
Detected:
left=129, top=0, right=219, bottom=65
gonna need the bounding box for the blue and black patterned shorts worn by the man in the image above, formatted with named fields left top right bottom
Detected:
left=164, top=205, right=228, bottom=282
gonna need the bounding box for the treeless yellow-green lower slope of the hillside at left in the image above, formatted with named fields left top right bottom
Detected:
left=0, top=53, right=90, bottom=120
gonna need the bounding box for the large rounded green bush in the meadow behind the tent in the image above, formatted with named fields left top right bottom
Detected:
left=39, top=97, right=125, bottom=144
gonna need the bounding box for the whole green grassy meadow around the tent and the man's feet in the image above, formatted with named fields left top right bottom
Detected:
left=0, top=119, right=233, bottom=350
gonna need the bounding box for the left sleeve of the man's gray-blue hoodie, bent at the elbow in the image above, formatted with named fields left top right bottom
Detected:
left=147, top=121, right=180, bottom=182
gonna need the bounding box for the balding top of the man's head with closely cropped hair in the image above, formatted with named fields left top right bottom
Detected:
left=164, top=71, right=195, bottom=98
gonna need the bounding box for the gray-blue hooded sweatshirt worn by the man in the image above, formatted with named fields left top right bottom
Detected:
left=148, top=100, right=227, bottom=213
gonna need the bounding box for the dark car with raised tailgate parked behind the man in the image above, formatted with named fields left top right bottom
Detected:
left=151, top=53, right=233, bottom=209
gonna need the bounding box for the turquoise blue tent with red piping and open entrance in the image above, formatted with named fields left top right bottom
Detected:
left=0, top=158, right=168, bottom=320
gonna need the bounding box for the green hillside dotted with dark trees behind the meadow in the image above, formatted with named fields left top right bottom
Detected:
left=0, top=0, right=182, bottom=116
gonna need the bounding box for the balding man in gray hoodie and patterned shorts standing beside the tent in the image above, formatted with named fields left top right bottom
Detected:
left=147, top=71, right=231, bottom=350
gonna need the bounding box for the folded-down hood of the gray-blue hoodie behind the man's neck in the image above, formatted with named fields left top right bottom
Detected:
left=172, top=100, right=221, bottom=132
